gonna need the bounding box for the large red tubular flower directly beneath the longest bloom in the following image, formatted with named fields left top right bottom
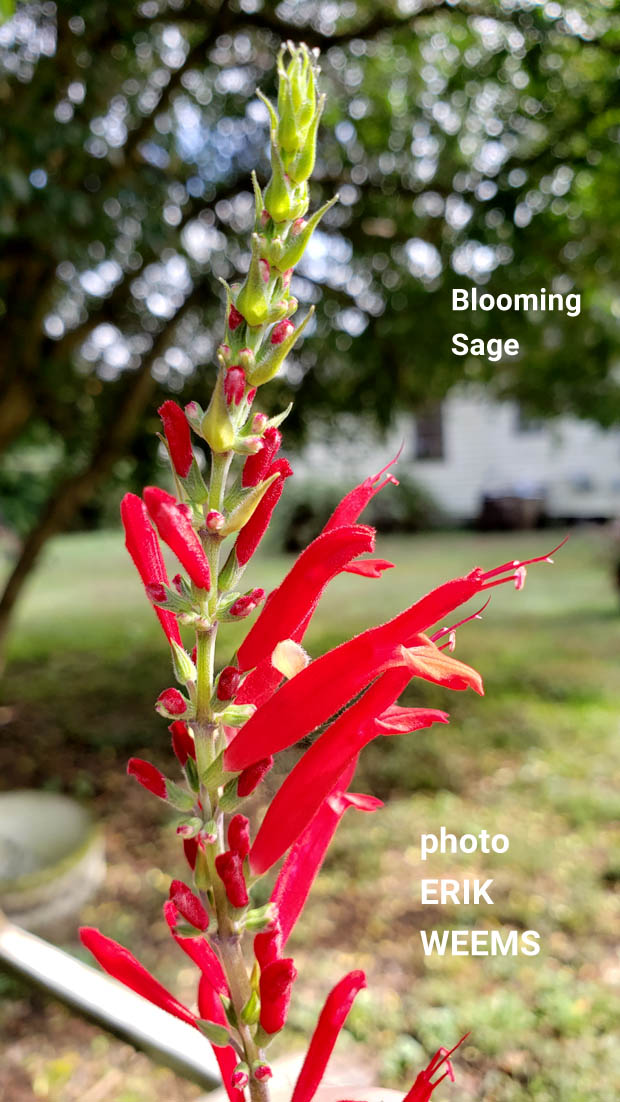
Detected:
left=250, top=670, right=448, bottom=874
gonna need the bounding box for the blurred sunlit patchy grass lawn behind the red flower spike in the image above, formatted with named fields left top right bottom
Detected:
left=0, top=529, right=620, bottom=1102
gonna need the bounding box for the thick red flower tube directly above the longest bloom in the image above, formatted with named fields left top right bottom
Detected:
left=238, top=525, right=374, bottom=670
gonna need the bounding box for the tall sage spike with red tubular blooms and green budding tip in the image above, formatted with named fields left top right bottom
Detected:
left=77, top=45, right=557, bottom=1102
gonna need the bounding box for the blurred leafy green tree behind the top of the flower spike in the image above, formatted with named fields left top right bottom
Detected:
left=0, top=0, right=620, bottom=652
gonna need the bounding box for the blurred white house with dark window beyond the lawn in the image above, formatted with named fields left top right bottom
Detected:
left=300, top=387, right=620, bottom=521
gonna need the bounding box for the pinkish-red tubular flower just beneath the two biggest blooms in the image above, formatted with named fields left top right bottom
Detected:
left=271, top=760, right=381, bottom=949
